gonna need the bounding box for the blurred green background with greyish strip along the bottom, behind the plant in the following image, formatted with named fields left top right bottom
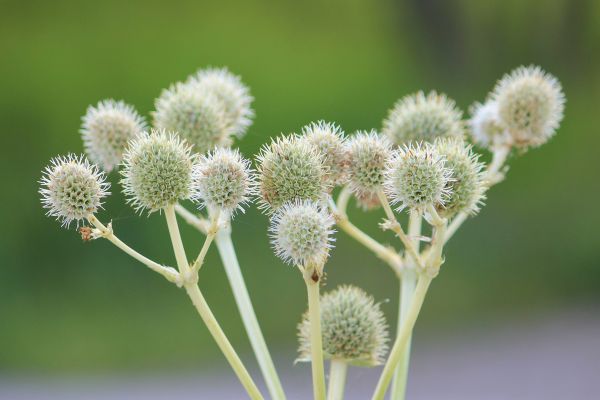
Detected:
left=0, top=0, right=600, bottom=399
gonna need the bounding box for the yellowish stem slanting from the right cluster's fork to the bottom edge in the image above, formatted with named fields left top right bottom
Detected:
left=372, top=274, right=432, bottom=400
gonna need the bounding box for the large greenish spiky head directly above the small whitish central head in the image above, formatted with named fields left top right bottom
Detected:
left=257, top=135, right=328, bottom=210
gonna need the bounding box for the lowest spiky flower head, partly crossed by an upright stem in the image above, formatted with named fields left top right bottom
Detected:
left=298, top=286, right=388, bottom=366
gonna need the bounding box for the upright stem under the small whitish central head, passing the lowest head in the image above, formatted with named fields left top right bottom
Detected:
left=304, top=268, right=325, bottom=400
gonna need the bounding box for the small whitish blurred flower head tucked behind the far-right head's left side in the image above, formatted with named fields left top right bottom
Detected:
left=469, top=100, right=512, bottom=150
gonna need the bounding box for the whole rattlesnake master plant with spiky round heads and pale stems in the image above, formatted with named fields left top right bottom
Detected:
left=39, top=63, right=565, bottom=400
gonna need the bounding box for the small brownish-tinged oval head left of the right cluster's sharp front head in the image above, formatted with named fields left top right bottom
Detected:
left=349, top=130, right=391, bottom=198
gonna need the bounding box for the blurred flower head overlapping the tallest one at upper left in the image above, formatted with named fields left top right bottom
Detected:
left=152, top=83, right=231, bottom=153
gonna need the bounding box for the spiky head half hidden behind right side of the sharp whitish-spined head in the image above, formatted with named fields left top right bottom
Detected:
left=435, top=138, right=485, bottom=217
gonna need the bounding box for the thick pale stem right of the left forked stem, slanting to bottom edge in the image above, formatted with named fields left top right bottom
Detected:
left=215, top=221, right=285, bottom=400
